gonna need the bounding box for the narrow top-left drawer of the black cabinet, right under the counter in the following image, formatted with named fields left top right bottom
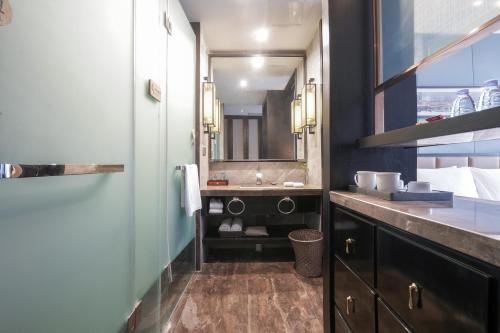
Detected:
left=334, top=208, right=375, bottom=288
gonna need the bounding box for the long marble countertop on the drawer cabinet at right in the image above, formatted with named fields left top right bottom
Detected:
left=330, top=191, right=500, bottom=266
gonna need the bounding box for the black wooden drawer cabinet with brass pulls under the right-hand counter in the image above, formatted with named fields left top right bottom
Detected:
left=331, top=205, right=500, bottom=333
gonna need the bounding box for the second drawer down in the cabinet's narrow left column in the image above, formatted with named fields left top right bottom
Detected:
left=334, top=257, right=375, bottom=333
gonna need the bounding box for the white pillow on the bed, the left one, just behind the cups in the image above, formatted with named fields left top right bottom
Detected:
left=417, top=167, right=479, bottom=198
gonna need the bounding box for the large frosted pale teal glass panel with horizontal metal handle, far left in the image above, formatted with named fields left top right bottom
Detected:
left=0, top=0, right=134, bottom=333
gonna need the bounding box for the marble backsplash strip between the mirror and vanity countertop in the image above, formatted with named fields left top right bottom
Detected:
left=208, top=161, right=307, bottom=186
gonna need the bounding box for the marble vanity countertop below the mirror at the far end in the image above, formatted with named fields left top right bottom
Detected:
left=201, top=184, right=323, bottom=196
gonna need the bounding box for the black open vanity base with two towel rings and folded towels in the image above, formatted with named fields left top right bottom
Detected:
left=202, top=196, right=320, bottom=259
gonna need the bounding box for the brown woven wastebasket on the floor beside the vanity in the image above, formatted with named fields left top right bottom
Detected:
left=288, top=229, right=323, bottom=277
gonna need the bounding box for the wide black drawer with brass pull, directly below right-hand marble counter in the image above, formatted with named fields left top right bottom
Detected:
left=377, top=228, right=493, bottom=333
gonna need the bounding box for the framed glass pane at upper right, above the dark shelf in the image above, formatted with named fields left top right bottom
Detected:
left=378, top=0, right=500, bottom=84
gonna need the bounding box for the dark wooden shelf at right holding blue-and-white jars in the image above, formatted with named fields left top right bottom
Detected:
left=358, top=107, right=500, bottom=148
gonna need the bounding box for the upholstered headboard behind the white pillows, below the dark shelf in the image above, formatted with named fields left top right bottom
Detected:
left=417, top=155, right=500, bottom=169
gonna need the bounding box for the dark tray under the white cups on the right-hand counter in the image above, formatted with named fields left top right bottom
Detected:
left=349, top=185, right=453, bottom=201
